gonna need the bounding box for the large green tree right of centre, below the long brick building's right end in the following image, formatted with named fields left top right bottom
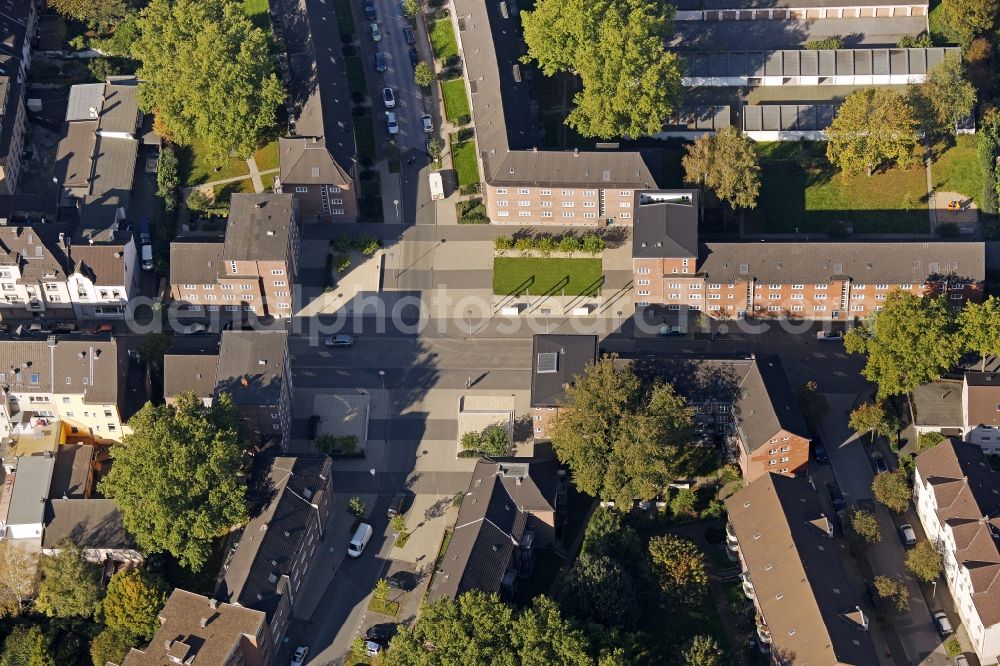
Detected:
left=844, top=290, right=962, bottom=400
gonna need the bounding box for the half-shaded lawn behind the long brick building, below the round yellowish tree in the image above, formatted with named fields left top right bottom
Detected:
left=747, top=141, right=929, bottom=234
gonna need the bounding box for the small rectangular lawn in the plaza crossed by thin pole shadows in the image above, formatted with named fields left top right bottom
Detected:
left=493, top=257, right=604, bottom=296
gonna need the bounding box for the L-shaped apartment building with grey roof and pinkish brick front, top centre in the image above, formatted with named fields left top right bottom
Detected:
left=452, top=0, right=658, bottom=226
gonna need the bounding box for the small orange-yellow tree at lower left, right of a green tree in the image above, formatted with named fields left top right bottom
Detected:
left=101, top=569, right=167, bottom=641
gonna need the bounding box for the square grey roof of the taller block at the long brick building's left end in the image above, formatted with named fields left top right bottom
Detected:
left=632, top=190, right=698, bottom=259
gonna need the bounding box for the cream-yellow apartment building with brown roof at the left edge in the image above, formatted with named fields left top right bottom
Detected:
left=0, top=336, right=138, bottom=443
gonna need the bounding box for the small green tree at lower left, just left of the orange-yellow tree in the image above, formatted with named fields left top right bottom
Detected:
left=35, top=539, right=101, bottom=618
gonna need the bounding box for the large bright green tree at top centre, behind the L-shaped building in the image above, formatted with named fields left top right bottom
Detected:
left=521, top=0, right=681, bottom=138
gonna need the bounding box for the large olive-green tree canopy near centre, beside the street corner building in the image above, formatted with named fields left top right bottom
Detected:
left=550, top=357, right=694, bottom=506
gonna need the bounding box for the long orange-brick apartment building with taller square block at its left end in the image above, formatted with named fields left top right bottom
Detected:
left=632, top=190, right=986, bottom=321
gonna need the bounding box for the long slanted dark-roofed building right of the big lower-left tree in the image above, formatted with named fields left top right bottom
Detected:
left=217, top=454, right=333, bottom=618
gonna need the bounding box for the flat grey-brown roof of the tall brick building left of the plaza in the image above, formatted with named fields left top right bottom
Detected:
left=228, top=194, right=295, bottom=261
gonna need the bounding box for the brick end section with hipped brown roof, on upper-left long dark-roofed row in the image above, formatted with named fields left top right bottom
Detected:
left=274, top=137, right=358, bottom=222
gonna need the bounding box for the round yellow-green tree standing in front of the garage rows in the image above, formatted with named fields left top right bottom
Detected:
left=826, top=88, right=919, bottom=176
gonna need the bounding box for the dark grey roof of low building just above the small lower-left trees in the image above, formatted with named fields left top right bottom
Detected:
left=42, top=499, right=136, bottom=550
